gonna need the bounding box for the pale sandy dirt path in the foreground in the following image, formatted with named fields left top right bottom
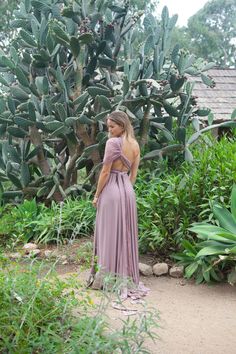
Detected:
left=61, top=272, right=236, bottom=354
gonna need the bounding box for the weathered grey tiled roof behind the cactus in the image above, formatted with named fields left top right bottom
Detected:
left=189, top=69, right=236, bottom=121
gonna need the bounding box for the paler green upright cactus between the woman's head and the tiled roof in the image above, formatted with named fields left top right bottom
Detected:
left=118, top=7, right=236, bottom=160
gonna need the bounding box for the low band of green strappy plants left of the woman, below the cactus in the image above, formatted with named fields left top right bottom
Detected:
left=0, top=198, right=95, bottom=247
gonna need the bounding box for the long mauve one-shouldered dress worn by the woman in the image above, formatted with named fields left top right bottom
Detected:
left=91, top=137, right=147, bottom=296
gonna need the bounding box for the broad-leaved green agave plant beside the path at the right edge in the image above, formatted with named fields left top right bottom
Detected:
left=174, top=185, right=236, bottom=284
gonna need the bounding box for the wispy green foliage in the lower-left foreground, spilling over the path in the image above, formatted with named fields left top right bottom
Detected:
left=0, top=257, right=159, bottom=354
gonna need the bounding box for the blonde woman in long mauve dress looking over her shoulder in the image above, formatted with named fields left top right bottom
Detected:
left=89, top=111, right=147, bottom=297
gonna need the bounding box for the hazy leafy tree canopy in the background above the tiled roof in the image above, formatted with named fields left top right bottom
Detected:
left=185, top=0, right=236, bottom=67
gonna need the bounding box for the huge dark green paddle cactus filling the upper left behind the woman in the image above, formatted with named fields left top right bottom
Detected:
left=0, top=0, right=142, bottom=199
